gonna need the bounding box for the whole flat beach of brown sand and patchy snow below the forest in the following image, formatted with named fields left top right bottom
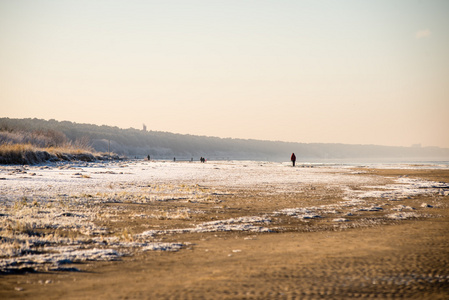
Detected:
left=0, top=160, right=449, bottom=299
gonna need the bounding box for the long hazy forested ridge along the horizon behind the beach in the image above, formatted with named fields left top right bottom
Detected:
left=0, top=118, right=449, bottom=162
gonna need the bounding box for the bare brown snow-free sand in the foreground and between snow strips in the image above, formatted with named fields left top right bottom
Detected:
left=0, top=168, right=449, bottom=299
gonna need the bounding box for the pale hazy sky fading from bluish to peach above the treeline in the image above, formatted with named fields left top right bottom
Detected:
left=0, top=0, right=449, bottom=147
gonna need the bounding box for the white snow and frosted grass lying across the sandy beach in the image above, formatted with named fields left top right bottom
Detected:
left=0, top=161, right=449, bottom=272
